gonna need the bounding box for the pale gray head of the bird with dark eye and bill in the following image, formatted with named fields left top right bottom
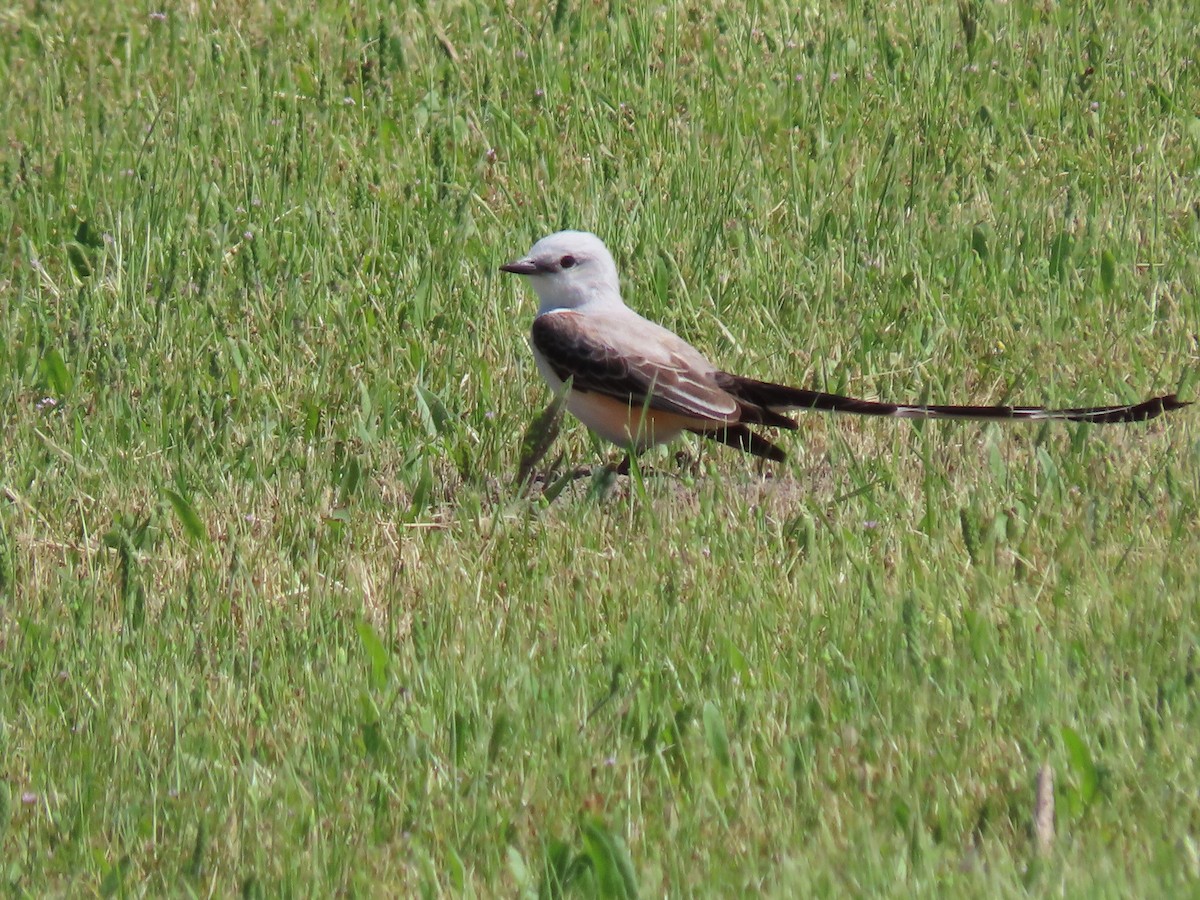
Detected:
left=500, top=232, right=620, bottom=314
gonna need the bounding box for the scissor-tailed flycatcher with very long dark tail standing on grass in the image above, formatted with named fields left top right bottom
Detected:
left=500, top=232, right=1188, bottom=461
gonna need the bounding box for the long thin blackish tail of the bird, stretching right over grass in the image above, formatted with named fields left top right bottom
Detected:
left=718, top=372, right=1190, bottom=427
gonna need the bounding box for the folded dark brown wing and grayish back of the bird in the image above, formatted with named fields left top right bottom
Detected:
left=533, top=310, right=740, bottom=424
